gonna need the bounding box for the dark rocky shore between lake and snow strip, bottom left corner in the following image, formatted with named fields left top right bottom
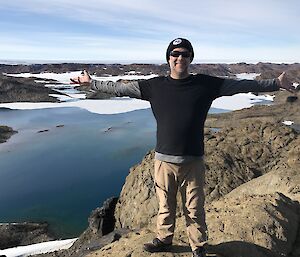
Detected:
left=0, top=222, right=53, bottom=249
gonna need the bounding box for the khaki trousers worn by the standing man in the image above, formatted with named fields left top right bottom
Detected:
left=154, top=160, right=207, bottom=251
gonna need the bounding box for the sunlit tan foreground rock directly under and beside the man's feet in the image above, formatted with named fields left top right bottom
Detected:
left=87, top=193, right=299, bottom=257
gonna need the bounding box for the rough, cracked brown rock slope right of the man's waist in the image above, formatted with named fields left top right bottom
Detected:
left=205, top=120, right=299, bottom=202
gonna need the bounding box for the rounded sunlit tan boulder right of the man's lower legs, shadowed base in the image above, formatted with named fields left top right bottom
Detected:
left=207, top=193, right=299, bottom=257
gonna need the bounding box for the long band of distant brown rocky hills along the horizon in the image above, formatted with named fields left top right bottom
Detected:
left=0, top=63, right=300, bottom=83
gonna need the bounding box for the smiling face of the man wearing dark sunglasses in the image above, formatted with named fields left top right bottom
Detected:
left=169, top=47, right=191, bottom=78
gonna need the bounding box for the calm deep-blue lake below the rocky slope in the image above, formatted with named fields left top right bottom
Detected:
left=0, top=105, right=225, bottom=238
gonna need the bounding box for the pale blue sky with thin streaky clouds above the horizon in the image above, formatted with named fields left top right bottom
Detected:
left=0, top=0, right=300, bottom=63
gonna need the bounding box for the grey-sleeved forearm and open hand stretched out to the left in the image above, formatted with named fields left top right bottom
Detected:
left=70, top=70, right=141, bottom=99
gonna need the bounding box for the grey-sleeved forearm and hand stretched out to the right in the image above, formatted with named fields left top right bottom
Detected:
left=220, top=72, right=295, bottom=96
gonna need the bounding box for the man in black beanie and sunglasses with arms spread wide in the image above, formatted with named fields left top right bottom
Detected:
left=72, top=38, right=293, bottom=257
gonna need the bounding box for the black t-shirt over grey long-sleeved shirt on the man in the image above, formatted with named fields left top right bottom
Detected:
left=92, top=74, right=279, bottom=163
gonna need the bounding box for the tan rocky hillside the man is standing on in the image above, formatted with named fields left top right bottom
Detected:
left=28, top=91, right=300, bottom=257
